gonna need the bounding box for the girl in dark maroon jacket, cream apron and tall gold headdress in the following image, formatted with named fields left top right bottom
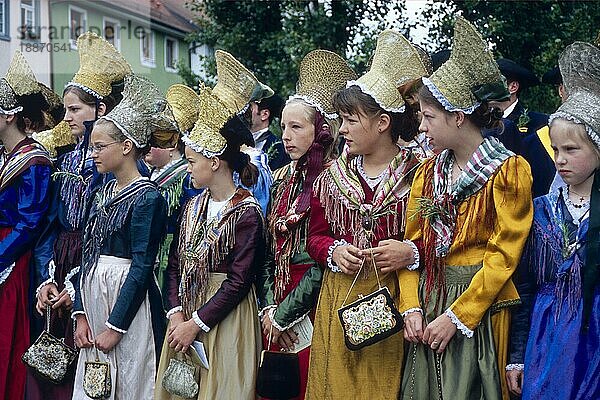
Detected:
left=155, top=83, right=265, bottom=400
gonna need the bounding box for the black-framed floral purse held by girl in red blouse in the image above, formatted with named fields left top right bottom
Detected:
left=338, top=247, right=404, bottom=351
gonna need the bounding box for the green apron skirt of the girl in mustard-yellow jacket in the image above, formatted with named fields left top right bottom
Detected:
left=400, top=265, right=502, bottom=400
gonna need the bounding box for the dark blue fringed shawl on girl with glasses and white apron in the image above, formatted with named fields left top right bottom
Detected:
left=82, top=178, right=156, bottom=279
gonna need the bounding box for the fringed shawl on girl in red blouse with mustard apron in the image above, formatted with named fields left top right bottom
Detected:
left=314, top=148, right=419, bottom=249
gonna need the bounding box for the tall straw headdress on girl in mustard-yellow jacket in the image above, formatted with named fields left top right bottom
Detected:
left=423, top=17, right=509, bottom=114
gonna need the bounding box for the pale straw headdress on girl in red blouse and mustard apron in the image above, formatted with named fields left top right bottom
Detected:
left=346, top=30, right=427, bottom=112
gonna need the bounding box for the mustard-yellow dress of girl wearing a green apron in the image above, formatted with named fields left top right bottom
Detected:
left=398, top=156, right=533, bottom=399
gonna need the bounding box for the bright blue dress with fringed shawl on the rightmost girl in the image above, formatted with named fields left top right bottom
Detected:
left=510, top=187, right=600, bottom=400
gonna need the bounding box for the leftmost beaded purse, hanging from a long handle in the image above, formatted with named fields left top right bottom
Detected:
left=21, top=306, right=77, bottom=384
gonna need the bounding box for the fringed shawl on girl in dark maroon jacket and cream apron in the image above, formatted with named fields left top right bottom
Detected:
left=179, top=188, right=262, bottom=319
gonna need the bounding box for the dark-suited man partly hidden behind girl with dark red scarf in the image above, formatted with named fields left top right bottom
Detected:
left=250, top=94, right=291, bottom=171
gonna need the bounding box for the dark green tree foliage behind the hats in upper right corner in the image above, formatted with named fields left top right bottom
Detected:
left=421, top=0, right=600, bottom=112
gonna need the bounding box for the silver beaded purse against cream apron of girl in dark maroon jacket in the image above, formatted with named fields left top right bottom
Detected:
left=162, top=353, right=199, bottom=399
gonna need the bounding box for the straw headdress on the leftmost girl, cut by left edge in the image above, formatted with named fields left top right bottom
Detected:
left=0, top=50, right=41, bottom=115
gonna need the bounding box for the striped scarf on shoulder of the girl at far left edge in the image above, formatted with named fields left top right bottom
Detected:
left=0, top=138, right=52, bottom=190
